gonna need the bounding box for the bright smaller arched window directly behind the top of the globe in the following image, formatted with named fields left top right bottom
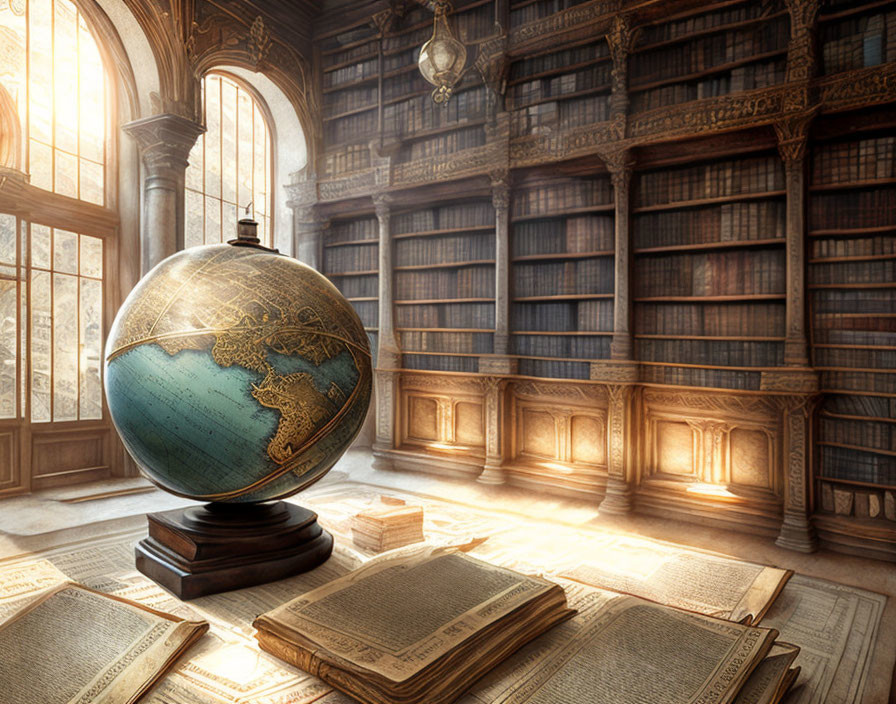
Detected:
left=184, top=73, right=273, bottom=247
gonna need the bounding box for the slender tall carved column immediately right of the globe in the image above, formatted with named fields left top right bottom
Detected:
left=373, top=194, right=401, bottom=469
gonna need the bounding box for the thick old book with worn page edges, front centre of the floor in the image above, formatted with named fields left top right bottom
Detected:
left=255, top=549, right=574, bottom=704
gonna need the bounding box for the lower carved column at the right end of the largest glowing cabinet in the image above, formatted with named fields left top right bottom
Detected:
left=775, top=395, right=818, bottom=552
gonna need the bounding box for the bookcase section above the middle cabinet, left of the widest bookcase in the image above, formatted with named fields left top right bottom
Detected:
left=510, top=174, right=614, bottom=379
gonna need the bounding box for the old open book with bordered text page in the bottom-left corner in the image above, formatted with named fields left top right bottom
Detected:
left=0, top=582, right=208, bottom=704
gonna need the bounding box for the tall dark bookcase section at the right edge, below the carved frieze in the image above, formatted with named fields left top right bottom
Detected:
left=809, top=131, right=896, bottom=520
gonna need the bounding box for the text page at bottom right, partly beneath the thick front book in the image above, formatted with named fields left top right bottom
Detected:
left=460, top=590, right=775, bottom=704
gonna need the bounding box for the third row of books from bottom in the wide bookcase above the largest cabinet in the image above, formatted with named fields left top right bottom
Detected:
left=634, top=301, right=786, bottom=337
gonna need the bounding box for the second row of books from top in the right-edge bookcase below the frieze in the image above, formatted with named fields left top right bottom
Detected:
left=809, top=187, right=896, bottom=230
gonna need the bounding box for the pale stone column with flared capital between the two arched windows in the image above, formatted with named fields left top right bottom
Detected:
left=123, top=114, right=205, bottom=274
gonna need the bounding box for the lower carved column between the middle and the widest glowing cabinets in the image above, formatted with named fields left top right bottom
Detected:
left=599, top=384, right=635, bottom=515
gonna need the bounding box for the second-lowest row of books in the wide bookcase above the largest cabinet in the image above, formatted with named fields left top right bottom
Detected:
left=635, top=340, right=784, bottom=367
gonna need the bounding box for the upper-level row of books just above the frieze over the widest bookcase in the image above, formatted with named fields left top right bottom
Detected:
left=630, top=56, right=787, bottom=113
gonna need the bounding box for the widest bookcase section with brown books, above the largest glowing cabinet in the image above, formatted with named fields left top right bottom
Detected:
left=632, top=152, right=786, bottom=390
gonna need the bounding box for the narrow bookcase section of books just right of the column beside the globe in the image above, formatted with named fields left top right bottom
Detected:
left=392, top=199, right=495, bottom=372
